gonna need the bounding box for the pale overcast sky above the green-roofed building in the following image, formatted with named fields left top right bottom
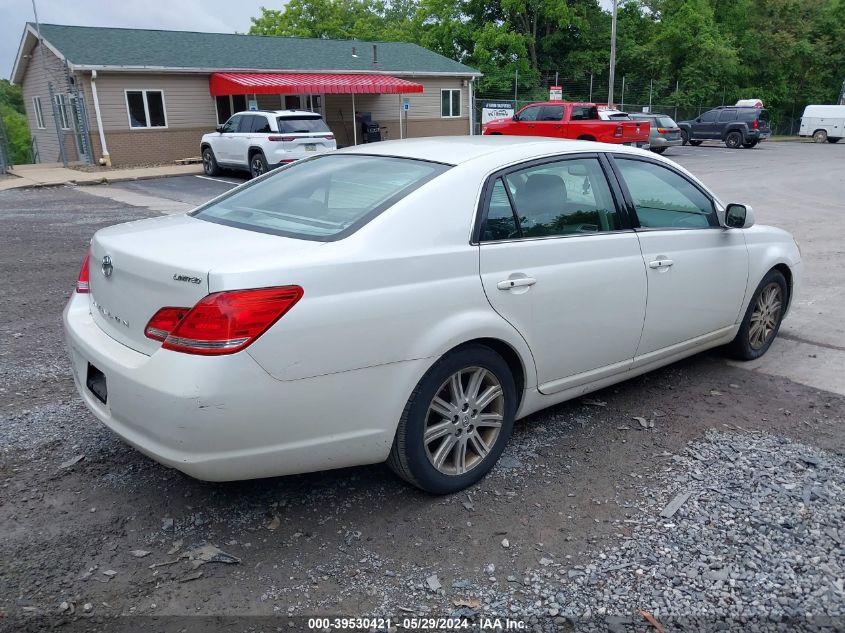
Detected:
left=0, top=0, right=270, bottom=79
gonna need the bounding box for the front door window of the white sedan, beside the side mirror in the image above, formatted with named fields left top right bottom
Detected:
left=614, top=158, right=719, bottom=229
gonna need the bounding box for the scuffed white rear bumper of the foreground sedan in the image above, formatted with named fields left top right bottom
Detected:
left=64, top=295, right=425, bottom=481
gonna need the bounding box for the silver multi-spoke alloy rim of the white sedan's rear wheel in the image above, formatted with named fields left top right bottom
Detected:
left=423, top=367, right=505, bottom=475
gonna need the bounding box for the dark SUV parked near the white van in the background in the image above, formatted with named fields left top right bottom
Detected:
left=678, top=106, right=771, bottom=149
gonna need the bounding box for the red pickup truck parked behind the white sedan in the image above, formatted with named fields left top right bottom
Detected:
left=483, top=101, right=650, bottom=148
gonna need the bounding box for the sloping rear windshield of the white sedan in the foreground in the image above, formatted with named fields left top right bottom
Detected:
left=192, top=154, right=449, bottom=241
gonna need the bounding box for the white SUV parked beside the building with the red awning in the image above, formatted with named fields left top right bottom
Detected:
left=200, top=110, right=337, bottom=178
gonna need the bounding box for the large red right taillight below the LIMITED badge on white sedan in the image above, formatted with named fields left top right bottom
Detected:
left=144, top=286, right=303, bottom=356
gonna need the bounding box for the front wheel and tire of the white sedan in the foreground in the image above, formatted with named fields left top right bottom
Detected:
left=729, top=269, right=789, bottom=360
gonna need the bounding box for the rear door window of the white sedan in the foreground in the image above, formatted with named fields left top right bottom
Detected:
left=481, top=158, right=622, bottom=241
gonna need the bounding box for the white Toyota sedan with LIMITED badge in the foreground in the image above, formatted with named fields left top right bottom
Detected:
left=64, top=136, right=801, bottom=493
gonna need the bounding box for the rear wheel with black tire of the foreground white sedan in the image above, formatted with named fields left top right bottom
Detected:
left=387, top=345, right=517, bottom=495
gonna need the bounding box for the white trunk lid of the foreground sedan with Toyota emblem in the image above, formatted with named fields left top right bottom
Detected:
left=89, top=215, right=320, bottom=354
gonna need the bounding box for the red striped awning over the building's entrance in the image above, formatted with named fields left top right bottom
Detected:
left=210, top=73, right=423, bottom=97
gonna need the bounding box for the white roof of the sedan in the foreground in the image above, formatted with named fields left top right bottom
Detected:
left=338, top=135, right=638, bottom=168
